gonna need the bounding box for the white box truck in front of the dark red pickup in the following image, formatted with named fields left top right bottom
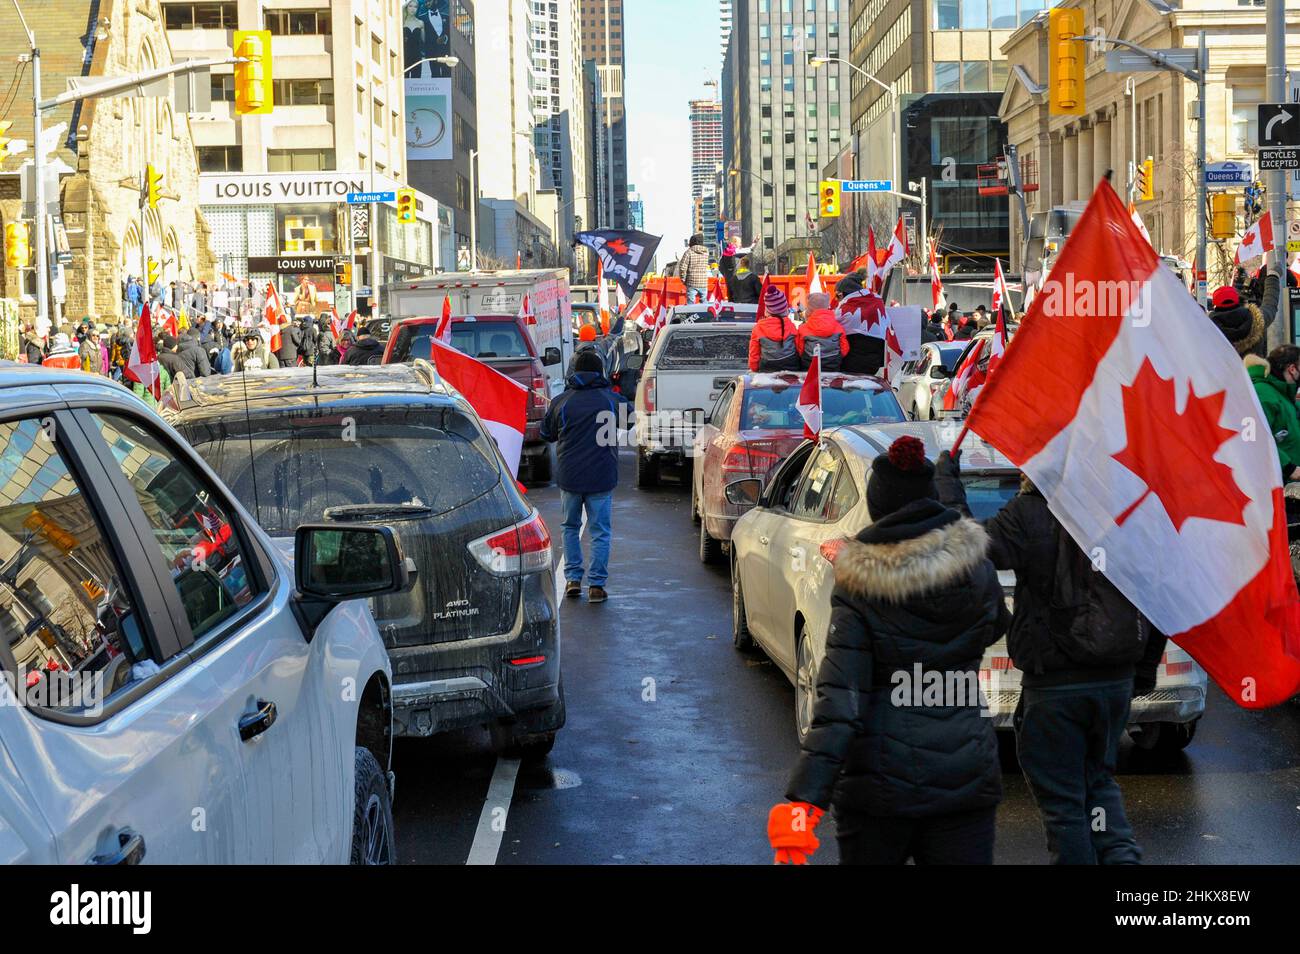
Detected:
left=385, top=268, right=573, bottom=398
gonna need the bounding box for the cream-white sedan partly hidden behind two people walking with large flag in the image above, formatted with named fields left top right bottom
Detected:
left=725, top=422, right=1206, bottom=753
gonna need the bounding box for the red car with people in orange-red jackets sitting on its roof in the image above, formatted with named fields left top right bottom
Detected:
left=690, top=372, right=907, bottom=563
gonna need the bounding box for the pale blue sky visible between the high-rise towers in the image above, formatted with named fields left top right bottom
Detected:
left=623, top=0, right=723, bottom=268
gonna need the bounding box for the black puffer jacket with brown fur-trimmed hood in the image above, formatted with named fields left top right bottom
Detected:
left=787, top=500, right=1010, bottom=818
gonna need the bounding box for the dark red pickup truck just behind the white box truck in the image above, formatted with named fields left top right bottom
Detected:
left=384, top=315, right=560, bottom=483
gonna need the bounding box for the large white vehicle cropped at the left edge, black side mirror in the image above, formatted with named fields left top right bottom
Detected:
left=0, top=365, right=410, bottom=864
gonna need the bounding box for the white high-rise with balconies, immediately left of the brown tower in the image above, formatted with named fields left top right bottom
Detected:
left=532, top=0, right=592, bottom=259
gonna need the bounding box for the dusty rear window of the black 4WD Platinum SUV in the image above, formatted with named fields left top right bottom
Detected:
left=181, top=406, right=501, bottom=535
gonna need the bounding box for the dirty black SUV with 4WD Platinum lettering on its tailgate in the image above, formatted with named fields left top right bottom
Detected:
left=163, top=361, right=564, bottom=758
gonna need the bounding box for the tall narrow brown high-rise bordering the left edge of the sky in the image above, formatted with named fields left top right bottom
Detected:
left=581, top=0, right=628, bottom=229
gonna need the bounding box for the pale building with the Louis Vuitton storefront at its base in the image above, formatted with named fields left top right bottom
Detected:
left=166, top=0, right=436, bottom=308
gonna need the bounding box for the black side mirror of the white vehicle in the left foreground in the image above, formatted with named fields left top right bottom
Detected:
left=294, top=524, right=415, bottom=603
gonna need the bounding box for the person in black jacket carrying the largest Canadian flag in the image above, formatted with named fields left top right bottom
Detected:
left=937, top=451, right=1165, bottom=864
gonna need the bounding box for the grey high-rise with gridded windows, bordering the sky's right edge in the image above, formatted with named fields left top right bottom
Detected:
left=723, top=0, right=849, bottom=255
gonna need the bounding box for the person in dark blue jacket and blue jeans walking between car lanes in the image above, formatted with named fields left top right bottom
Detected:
left=542, top=348, right=632, bottom=603
